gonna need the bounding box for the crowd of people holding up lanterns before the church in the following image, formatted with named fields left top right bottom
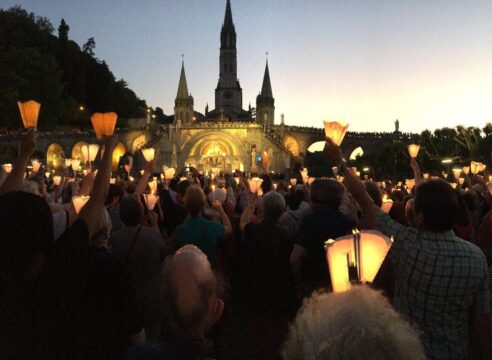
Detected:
left=0, top=134, right=492, bottom=360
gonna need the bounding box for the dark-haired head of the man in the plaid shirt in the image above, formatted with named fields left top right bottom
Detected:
left=415, top=179, right=459, bottom=233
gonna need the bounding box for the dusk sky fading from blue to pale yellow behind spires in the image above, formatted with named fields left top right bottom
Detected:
left=0, top=0, right=492, bottom=132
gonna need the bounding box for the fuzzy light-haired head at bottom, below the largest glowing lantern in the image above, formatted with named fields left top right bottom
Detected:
left=282, top=286, right=425, bottom=360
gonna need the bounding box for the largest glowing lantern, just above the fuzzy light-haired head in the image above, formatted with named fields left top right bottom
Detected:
left=325, top=231, right=392, bottom=293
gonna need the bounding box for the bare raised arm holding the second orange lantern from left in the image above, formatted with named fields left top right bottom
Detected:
left=79, top=135, right=118, bottom=238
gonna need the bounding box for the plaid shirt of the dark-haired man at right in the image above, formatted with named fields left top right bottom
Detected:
left=377, top=213, right=490, bottom=359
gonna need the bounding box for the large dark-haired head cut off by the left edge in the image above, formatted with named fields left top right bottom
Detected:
left=0, top=191, right=53, bottom=283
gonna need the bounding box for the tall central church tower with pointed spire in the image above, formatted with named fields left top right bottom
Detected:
left=215, top=0, right=244, bottom=118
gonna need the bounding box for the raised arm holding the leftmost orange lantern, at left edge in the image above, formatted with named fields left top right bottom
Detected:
left=0, top=133, right=36, bottom=194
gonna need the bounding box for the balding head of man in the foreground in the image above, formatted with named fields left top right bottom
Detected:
left=161, top=245, right=224, bottom=356
